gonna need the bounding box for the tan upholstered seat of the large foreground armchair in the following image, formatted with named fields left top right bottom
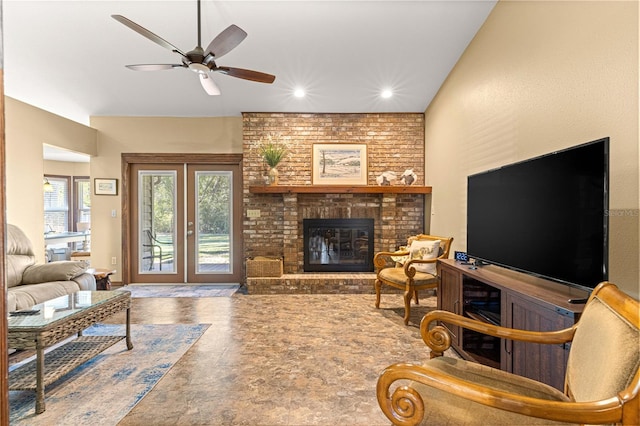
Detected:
left=411, top=357, right=569, bottom=425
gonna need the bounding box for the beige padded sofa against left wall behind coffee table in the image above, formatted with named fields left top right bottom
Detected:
left=6, top=225, right=96, bottom=311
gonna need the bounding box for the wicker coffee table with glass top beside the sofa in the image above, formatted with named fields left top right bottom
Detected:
left=7, top=291, right=133, bottom=414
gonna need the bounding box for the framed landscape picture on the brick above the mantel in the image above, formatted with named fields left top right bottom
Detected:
left=311, top=143, right=367, bottom=185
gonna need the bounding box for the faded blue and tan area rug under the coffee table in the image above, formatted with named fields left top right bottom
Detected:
left=9, top=324, right=209, bottom=425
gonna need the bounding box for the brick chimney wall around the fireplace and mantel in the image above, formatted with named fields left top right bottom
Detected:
left=243, top=113, right=425, bottom=273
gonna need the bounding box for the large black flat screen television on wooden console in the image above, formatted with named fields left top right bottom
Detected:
left=467, top=138, right=609, bottom=291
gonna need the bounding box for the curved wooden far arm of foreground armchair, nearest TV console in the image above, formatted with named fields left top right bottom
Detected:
left=420, top=310, right=576, bottom=358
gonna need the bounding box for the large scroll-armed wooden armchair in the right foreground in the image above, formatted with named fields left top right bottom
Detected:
left=377, top=283, right=640, bottom=425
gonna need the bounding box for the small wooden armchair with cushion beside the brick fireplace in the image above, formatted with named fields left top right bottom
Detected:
left=373, top=234, right=453, bottom=324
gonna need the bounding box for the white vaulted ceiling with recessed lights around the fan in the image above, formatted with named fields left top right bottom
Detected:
left=2, top=0, right=496, bottom=161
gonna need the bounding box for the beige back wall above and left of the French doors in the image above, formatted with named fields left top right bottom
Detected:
left=91, top=117, right=242, bottom=281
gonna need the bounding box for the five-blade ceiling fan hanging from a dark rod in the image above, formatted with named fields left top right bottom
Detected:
left=111, top=0, right=276, bottom=96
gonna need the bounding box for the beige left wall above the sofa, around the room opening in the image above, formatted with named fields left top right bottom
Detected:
left=5, top=97, right=97, bottom=262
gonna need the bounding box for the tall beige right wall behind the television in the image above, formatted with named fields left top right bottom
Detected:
left=425, top=1, right=640, bottom=297
